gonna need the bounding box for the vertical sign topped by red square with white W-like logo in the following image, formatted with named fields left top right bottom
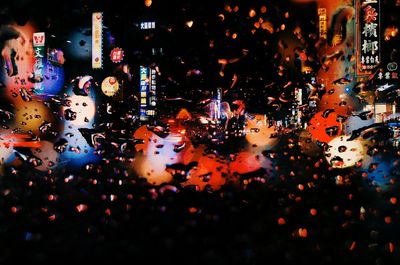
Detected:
left=33, top=32, right=45, bottom=94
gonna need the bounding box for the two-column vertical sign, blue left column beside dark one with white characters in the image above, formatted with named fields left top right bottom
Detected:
left=140, top=66, right=157, bottom=121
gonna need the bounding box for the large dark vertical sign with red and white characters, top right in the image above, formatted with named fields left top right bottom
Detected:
left=356, top=0, right=381, bottom=76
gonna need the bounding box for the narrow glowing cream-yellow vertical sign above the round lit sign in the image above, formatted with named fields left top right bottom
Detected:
left=92, top=12, right=103, bottom=69
